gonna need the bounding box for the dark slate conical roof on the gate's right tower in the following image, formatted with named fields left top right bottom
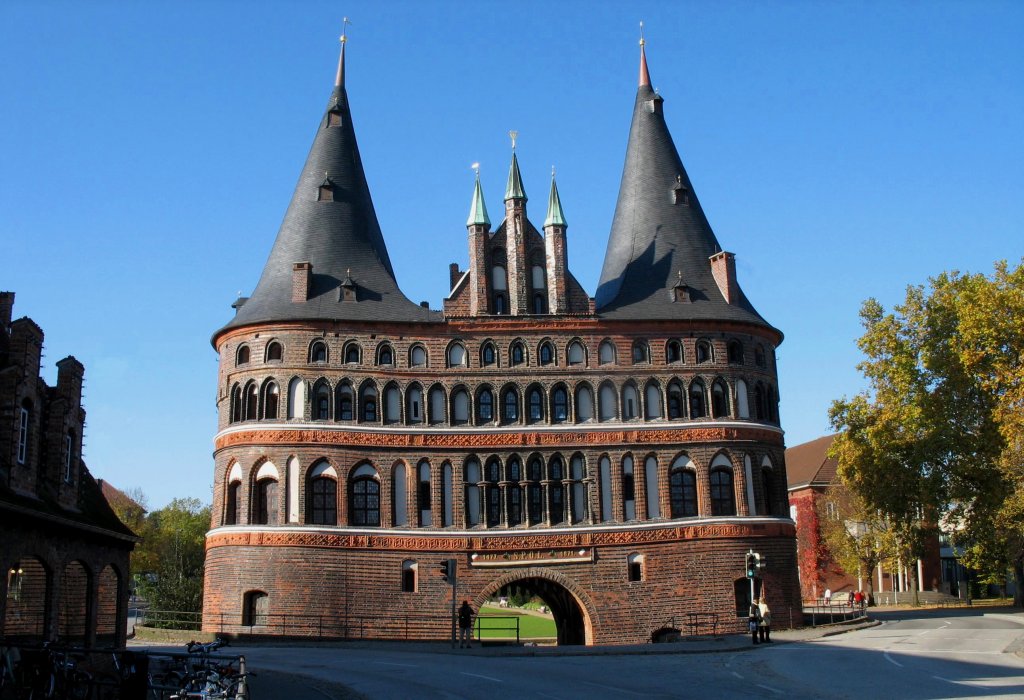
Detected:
left=595, top=45, right=769, bottom=333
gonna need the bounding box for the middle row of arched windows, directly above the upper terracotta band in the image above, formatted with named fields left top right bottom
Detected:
left=229, top=377, right=778, bottom=426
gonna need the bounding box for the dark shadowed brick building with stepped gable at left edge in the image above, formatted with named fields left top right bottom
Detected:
left=0, top=292, right=137, bottom=646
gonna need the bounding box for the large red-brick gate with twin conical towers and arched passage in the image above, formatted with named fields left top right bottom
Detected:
left=204, top=34, right=801, bottom=644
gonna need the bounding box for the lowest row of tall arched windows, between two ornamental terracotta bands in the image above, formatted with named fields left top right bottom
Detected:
left=222, top=452, right=782, bottom=528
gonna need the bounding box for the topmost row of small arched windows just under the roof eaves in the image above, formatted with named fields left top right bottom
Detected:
left=234, top=338, right=767, bottom=367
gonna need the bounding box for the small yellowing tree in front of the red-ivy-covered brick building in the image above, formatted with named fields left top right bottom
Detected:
left=817, top=479, right=897, bottom=601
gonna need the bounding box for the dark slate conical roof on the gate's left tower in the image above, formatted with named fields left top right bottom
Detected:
left=225, top=40, right=440, bottom=329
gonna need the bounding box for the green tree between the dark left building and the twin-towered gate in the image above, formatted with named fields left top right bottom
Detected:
left=137, top=498, right=210, bottom=612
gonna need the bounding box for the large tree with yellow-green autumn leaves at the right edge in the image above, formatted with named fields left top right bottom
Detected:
left=829, top=263, right=1024, bottom=605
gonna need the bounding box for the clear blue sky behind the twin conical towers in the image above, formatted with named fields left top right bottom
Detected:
left=0, top=0, right=1024, bottom=508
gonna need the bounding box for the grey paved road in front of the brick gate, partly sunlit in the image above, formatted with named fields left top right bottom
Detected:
left=142, top=610, right=1024, bottom=700
